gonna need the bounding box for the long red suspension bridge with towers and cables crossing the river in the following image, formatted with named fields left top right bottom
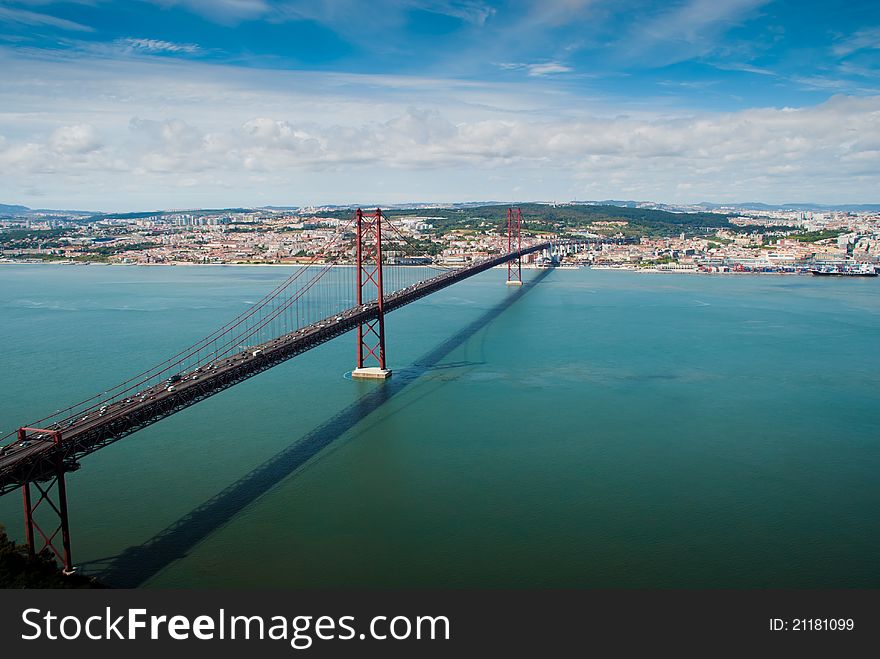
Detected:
left=0, top=208, right=617, bottom=572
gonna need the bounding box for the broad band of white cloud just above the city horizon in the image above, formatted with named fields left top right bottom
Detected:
left=0, top=53, right=880, bottom=208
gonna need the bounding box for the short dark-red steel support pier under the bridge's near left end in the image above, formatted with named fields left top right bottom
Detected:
left=18, top=428, right=74, bottom=574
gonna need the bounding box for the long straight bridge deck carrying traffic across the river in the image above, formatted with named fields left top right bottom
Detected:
left=0, top=242, right=550, bottom=495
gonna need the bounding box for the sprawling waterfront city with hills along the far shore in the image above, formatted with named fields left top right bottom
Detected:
left=0, top=202, right=880, bottom=273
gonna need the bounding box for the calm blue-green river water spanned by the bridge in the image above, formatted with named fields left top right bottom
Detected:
left=0, top=266, right=880, bottom=587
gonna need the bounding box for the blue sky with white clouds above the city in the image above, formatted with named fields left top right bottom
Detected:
left=0, top=0, right=880, bottom=211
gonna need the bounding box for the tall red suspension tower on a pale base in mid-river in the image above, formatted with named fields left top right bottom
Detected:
left=351, top=208, right=391, bottom=380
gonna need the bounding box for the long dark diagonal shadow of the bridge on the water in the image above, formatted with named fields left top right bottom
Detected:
left=93, top=270, right=550, bottom=588
